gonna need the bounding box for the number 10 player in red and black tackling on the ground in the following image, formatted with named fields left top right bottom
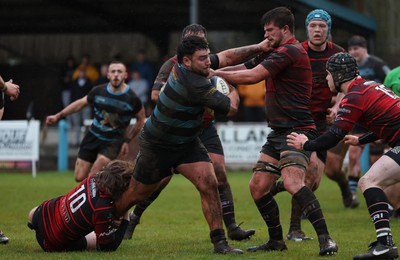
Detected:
left=28, top=160, right=134, bottom=252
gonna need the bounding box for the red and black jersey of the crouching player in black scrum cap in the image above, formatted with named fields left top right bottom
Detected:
left=334, top=77, right=400, bottom=147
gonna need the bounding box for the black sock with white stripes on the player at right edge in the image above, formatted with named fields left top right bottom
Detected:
left=363, top=188, right=393, bottom=246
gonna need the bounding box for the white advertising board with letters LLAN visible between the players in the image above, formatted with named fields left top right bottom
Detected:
left=216, top=123, right=271, bottom=166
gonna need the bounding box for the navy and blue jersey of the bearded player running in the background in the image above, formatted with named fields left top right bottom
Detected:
left=87, top=83, right=142, bottom=141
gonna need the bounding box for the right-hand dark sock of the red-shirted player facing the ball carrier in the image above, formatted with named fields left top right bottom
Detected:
left=293, top=186, right=329, bottom=236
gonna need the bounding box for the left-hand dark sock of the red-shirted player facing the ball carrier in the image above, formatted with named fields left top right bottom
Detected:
left=254, top=193, right=283, bottom=240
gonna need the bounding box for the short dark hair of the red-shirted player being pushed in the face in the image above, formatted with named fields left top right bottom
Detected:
left=261, top=6, right=294, bottom=33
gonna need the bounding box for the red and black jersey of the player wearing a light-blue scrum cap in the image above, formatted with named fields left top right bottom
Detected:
left=302, top=40, right=345, bottom=128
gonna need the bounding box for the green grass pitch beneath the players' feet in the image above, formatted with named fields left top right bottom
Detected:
left=0, top=171, right=400, bottom=260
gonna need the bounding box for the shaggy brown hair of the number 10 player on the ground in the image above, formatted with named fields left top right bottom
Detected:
left=95, top=160, right=134, bottom=200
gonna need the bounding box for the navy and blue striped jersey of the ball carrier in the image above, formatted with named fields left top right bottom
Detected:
left=144, top=64, right=230, bottom=148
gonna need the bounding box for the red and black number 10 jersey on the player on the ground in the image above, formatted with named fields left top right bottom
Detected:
left=41, top=175, right=119, bottom=251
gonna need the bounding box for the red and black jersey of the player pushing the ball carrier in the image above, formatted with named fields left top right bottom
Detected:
left=261, top=37, right=315, bottom=128
